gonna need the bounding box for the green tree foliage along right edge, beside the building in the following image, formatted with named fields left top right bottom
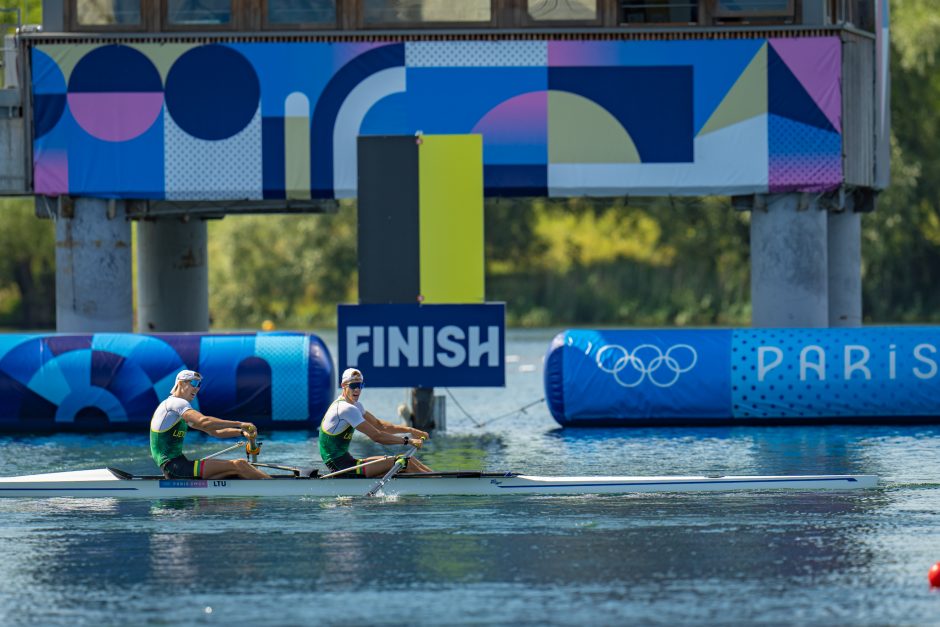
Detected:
left=862, top=0, right=940, bottom=322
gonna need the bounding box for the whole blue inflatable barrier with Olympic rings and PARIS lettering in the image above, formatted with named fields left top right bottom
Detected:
left=545, top=327, right=940, bottom=426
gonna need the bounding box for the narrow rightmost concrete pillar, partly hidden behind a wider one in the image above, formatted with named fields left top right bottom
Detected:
left=828, top=209, right=862, bottom=327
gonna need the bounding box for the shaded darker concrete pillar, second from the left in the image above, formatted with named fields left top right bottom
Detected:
left=137, top=217, right=209, bottom=333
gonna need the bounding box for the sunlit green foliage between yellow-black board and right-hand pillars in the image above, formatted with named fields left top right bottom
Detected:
left=487, top=198, right=750, bottom=326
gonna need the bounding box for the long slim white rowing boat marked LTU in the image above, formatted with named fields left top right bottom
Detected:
left=0, top=468, right=878, bottom=498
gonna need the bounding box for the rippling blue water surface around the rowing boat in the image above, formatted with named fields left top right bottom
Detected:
left=0, top=332, right=940, bottom=625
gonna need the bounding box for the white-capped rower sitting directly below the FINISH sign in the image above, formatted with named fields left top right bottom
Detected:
left=318, top=368, right=431, bottom=477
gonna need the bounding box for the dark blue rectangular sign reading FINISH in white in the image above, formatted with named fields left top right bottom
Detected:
left=337, top=303, right=506, bottom=387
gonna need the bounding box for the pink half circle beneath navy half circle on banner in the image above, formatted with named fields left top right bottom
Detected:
left=68, top=92, right=163, bottom=142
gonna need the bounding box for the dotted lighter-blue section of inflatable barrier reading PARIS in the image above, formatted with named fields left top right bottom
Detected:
left=731, top=327, right=940, bottom=418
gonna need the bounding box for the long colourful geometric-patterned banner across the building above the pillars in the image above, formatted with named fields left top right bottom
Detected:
left=31, top=37, right=842, bottom=200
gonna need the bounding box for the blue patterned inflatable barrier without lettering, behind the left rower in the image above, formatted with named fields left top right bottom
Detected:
left=0, top=332, right=335, bottom=432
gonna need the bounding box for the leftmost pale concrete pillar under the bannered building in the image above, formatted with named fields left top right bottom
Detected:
left=55, top=198, right=134, bottom=333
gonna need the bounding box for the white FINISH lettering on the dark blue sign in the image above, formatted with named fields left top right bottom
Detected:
left=346, top=325, right=501, bottom=368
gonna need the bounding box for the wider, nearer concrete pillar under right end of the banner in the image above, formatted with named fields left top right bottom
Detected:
left=751, top=194, right=829, bottom=328
